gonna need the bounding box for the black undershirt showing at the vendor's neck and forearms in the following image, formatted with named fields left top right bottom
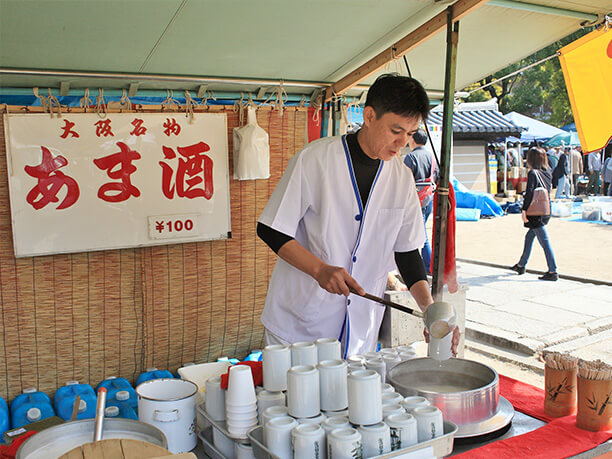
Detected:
left=257, top=134, right=427, bottom=288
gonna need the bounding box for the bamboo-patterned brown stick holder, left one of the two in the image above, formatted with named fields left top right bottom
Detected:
left=544, top=366, right=578, bottom=418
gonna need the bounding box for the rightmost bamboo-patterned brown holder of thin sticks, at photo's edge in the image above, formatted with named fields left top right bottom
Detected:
left=576, top=377, right=612, bottom=432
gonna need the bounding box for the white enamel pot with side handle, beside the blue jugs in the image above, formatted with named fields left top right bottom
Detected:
left=136, top=378, right=198, bottom=454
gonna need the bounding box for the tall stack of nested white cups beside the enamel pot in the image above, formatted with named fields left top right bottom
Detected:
left=225, top=365, right=257, bottom=438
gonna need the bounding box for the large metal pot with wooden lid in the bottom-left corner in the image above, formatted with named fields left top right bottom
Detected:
left=15, top=418, right=168, bottom=459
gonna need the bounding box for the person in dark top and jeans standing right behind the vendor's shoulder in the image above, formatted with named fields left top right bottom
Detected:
left=404, top=129, right=439, bottom=273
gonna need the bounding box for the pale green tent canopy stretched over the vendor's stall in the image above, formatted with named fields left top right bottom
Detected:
left=0, top=0, right=612, bottom=97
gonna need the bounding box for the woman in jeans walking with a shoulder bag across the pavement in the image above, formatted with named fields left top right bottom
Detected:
left=510, top=148, right=559, bottom=281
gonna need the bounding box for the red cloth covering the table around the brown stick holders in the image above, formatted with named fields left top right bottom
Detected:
left=453, top=375, right=612, bottom=459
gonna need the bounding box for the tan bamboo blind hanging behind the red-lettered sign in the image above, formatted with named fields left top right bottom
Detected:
left=0, top=107, right=307, bottom=400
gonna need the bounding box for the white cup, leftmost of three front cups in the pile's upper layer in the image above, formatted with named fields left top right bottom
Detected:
left=287, top=366, right=321, bottom=418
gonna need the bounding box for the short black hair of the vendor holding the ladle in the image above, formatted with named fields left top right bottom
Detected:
left=365, top=73, right=429, bottom=121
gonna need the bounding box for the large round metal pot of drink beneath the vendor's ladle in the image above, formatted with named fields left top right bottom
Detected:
left=388, top=359, right=504, bottom=436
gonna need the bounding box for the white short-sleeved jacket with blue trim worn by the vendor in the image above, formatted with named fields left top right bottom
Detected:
left=259, top=136, right=425, bottom=355
